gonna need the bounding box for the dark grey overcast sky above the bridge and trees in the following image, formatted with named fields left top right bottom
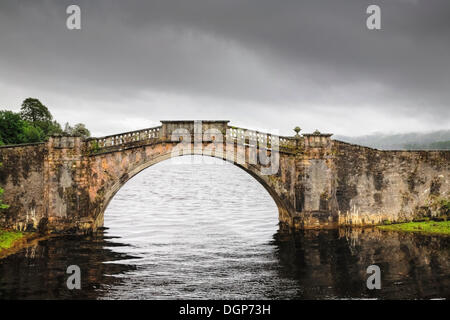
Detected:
left=0, top=0, right=450, bottom=136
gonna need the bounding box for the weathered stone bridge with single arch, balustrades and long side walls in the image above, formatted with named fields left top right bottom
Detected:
left=0, top=121, right=450, bottom=232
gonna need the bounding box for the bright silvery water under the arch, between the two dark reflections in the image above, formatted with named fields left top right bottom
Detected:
left=101, top=157, right=279, bottom=298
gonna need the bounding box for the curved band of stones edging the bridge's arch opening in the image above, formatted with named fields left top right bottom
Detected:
left=94, top=150, right=288, bottom=226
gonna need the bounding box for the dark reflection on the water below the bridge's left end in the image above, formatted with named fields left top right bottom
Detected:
left=0, top=233, right=135, bottom=299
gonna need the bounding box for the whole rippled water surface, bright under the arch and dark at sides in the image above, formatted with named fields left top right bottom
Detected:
left=0, top=157, right=450, bottom=299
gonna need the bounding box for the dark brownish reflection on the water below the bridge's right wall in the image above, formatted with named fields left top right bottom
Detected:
left=275, top=228, right=450, bottom=299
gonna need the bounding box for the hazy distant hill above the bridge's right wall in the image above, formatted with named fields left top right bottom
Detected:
left=333, top=130, right=450, bottom=150
